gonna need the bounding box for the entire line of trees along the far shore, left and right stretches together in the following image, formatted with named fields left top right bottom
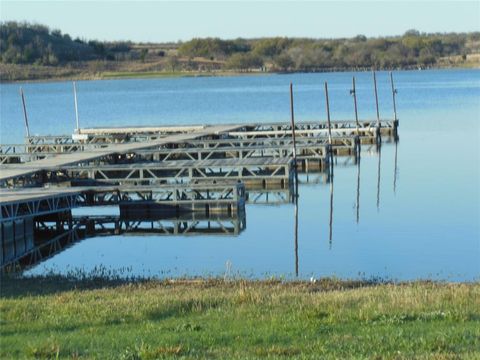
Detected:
left=0, top=22, right=480, bottom=72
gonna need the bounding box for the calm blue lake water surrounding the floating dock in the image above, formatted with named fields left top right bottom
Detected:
left=0, top=70, right=480, bottom=281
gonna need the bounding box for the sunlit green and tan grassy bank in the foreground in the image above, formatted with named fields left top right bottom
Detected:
left=0, top=278, right=480, bottom=359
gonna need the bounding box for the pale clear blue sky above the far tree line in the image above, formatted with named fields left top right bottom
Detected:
left=0, top=0, right=480, bottom=42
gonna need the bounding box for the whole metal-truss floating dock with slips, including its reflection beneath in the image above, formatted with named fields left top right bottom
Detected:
left=0, top=121, right=398, bottom=268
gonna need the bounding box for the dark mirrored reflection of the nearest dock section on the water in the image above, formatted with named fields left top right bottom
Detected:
left=4, top=211, right=246, bottom=271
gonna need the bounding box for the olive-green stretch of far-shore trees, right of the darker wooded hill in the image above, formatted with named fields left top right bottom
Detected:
left=179, top=30, right=480, bottom=71
